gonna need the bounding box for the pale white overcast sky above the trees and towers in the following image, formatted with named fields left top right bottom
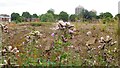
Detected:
left=0, top=0, right=120, bottom=15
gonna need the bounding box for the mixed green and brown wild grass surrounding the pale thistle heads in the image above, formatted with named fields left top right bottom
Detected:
left=3, top=22, right=118, bottom=66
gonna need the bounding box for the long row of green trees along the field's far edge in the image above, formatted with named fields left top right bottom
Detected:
left=11, top=9, right=120, bottom=23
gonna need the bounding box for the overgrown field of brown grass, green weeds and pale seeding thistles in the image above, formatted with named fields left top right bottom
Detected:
left=2, top=23, right=118, bottom=66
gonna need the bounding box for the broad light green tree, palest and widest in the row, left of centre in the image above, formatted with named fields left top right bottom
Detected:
left=40, top=13, right=54, bottom=22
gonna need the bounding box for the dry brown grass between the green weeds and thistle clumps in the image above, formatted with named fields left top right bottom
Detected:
left=3, top=23, right=117, bottom=65
